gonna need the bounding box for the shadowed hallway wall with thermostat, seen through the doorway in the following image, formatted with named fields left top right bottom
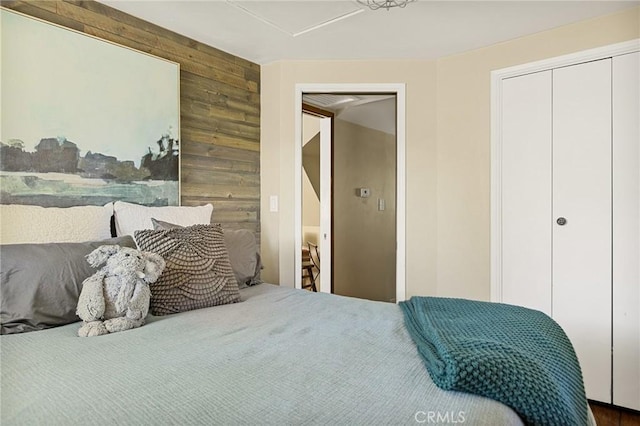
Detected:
left=333, top=119, right=396, bottom=302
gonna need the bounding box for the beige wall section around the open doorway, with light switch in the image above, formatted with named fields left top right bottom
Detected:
left=261, top=60, right=436, bottom=295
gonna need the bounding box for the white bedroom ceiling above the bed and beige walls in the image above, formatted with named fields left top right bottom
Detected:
left=100, top=0, right=640, bottom=64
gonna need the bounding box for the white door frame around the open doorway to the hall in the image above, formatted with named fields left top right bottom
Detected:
left=293, top=83, right=406, bottom=303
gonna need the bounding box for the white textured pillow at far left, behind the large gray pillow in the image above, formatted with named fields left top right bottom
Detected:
left=0, top=203, right=113, bottom=244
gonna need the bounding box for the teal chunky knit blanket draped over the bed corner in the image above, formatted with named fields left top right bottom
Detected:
left=400, top=297, right=588, bottom=426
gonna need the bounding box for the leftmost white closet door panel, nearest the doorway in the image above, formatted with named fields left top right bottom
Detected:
left=501, top=71, right=552, bottom=316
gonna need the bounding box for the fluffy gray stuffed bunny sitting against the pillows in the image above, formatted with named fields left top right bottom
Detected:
left=76, top=245, right=165, bottom=337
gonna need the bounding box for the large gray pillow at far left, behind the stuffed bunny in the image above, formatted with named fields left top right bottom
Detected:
left=0, top=236, right=136, bottom=334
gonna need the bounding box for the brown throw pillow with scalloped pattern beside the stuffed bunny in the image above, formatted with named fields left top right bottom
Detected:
left=135, top=225, right=240, bottom=315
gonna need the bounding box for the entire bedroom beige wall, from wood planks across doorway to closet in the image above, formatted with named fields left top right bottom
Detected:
left=261, top=8, right=640, bottom=300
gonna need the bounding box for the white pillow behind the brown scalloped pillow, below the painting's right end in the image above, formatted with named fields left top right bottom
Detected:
left=114, top=201, right=213, bottom=237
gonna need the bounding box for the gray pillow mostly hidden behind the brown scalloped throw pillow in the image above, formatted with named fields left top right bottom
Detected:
left=151, top=218, right=262, bottom=288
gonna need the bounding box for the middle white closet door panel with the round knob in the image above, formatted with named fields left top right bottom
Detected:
left=552, top=59, right=612, bottom=401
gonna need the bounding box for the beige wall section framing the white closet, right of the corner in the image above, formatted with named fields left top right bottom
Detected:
left=436, top=8, right=640, bottom=300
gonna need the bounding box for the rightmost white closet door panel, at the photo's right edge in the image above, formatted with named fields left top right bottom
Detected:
left=613, top=52, right=640, bottom=410
